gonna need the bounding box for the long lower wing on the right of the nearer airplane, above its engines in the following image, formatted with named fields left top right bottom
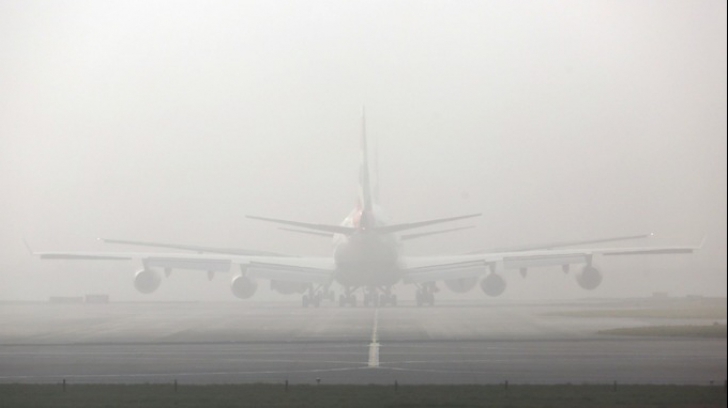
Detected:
left=402, top=239, right=702, bottom=283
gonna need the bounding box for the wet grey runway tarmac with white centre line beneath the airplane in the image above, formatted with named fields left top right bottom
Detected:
left=0, top=301, right=727, bottom=384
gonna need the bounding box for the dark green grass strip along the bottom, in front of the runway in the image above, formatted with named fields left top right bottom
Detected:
left=0, top=383, right=726, bottom=408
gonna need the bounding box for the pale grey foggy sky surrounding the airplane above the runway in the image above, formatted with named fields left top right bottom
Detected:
left=0, top=0, right=727, bottom=300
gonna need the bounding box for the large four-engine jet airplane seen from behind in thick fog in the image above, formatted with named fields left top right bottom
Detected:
left=28, top=109, right=702, bottom=307
